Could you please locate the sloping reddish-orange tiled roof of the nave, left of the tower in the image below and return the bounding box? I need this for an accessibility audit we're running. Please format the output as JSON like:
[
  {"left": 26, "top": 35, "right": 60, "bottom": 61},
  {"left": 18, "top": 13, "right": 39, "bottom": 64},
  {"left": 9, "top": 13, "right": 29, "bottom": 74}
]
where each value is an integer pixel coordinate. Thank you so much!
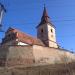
[{"left": 2, "top": 28, "right": 44, "bottom": 46}]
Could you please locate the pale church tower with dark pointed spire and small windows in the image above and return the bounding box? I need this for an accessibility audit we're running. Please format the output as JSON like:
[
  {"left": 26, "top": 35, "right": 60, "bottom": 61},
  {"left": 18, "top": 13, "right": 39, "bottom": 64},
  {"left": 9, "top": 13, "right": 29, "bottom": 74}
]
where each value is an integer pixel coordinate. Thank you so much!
[{"left": 37, "top": 6, "right": 58, "bottom": 48}]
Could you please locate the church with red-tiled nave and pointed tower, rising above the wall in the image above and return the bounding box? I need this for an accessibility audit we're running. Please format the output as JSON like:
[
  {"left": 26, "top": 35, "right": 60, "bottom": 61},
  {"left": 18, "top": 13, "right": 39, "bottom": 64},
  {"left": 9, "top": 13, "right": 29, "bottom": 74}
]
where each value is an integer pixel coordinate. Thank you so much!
[{"left": 2, "top": 6, "right": 59, "bottom": 48}]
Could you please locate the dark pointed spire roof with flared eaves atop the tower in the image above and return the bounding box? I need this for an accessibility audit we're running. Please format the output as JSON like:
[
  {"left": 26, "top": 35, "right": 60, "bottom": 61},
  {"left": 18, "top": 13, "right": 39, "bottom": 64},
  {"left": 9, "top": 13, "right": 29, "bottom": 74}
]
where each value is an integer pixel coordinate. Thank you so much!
[{"left": 37, "top": 6, "right": 55, "bottom": 27}]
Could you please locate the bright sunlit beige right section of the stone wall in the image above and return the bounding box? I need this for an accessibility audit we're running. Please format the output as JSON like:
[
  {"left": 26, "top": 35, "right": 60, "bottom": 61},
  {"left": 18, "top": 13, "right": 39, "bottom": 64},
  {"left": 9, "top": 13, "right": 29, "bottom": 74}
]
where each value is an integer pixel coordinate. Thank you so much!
[{"left": 33, "top": 45, "right": 75, "bottom": 64}]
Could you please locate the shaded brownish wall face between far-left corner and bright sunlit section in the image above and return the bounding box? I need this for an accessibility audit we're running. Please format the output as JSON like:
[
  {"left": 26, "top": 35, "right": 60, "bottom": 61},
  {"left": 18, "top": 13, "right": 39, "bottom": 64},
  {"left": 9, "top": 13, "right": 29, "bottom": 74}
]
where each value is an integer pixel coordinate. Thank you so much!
[{"left": 7, "top": 46, "right": 34, "bottom": 66}]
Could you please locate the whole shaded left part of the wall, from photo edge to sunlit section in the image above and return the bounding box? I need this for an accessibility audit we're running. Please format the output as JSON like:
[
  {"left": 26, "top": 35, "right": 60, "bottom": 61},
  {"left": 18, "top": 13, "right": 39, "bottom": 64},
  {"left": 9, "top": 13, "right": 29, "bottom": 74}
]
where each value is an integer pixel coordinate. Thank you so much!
[{"left": 0, "top": 46, "right": 34, "bottom": 66}]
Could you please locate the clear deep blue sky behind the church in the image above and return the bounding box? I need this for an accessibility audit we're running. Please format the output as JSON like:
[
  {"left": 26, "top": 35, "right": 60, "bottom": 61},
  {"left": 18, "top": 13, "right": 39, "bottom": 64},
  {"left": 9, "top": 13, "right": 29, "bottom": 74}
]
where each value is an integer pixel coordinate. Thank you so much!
[{"left": 0, "top": 0, "right": 75, "bottom": 52}]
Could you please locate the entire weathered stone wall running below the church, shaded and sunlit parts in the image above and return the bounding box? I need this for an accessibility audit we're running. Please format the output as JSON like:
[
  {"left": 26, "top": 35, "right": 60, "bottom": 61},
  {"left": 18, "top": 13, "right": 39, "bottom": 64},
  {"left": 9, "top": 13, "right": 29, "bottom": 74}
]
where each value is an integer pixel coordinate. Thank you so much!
[{"left": 0, "top": 45, "right": 75, "bottom": 66}]
